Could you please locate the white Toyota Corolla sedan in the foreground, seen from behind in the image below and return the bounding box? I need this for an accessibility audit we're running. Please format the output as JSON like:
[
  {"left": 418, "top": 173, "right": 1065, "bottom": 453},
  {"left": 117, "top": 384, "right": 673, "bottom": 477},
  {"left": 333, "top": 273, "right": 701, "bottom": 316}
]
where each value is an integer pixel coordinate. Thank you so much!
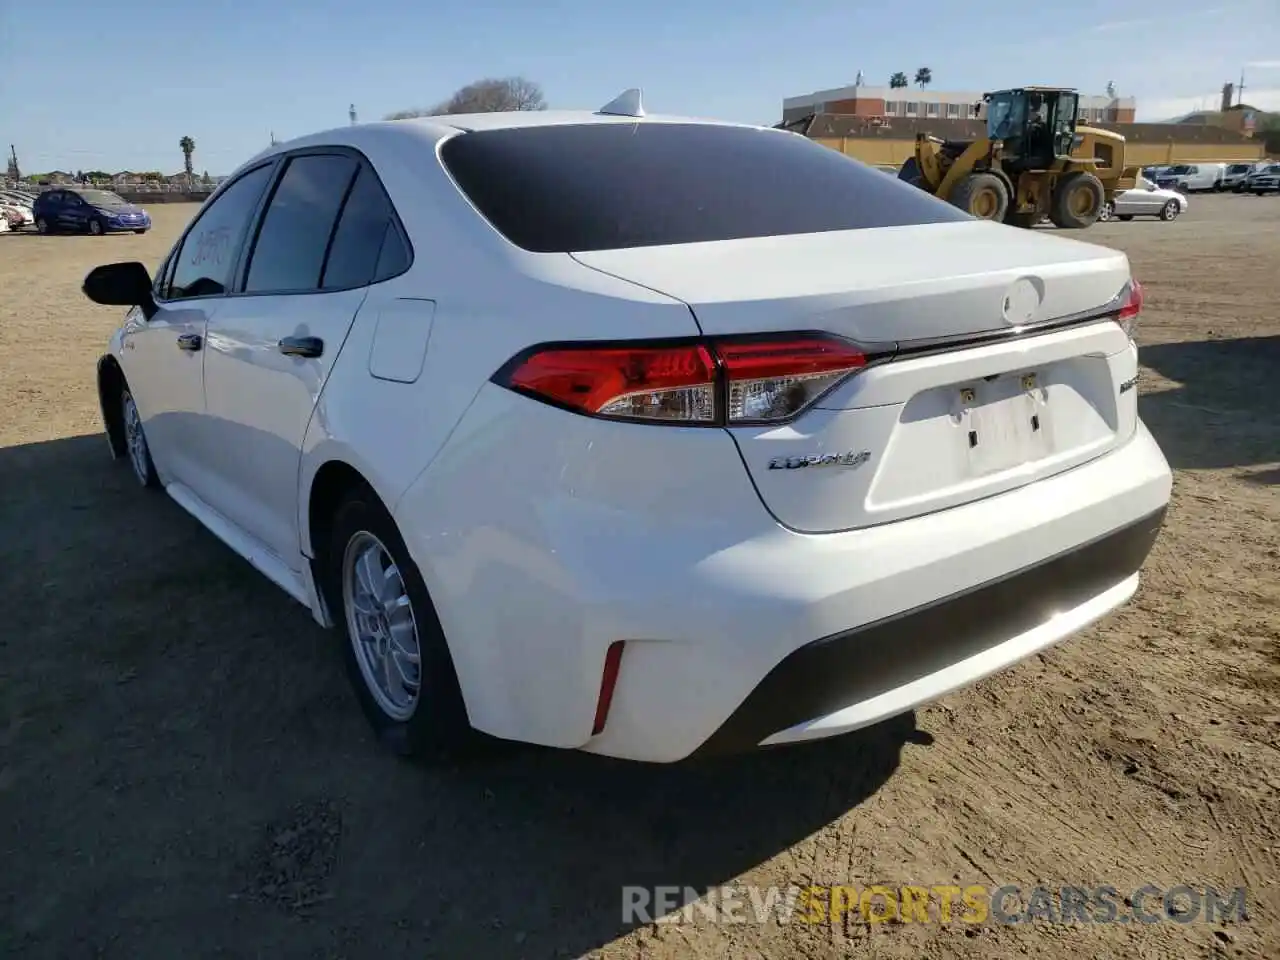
[{"left": 84, "top": 91, "right": 1171, "bottom": 762}]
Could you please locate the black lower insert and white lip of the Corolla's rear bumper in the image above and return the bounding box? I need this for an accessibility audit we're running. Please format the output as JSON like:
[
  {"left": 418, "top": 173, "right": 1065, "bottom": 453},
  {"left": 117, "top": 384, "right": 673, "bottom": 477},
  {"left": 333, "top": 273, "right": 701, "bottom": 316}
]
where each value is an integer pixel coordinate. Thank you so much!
[{"left": 696, "top": 508, "right": 1165, "bottom": 755}]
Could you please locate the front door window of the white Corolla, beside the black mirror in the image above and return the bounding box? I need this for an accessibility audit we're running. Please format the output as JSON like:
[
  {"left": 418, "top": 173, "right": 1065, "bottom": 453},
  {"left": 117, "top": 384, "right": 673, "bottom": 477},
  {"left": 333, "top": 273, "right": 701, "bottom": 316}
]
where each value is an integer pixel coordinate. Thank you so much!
[{"left": 168, "top": 164, "right": 271, "bottom": 300}]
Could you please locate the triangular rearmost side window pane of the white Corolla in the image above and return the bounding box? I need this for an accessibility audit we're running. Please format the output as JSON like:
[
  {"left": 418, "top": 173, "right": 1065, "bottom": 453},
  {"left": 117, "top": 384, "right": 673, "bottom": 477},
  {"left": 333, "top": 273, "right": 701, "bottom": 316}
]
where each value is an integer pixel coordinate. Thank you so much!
[{"left": 320, "top": 166, "right": 408, "bottom": 291}]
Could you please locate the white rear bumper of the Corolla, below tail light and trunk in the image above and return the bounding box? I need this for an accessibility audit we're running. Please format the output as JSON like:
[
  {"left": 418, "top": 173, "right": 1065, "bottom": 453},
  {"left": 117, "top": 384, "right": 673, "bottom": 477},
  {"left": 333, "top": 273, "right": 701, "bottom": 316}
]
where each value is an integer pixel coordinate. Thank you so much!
[{"left": 393, "top": 378, "right": 1171, "bottom": 763}]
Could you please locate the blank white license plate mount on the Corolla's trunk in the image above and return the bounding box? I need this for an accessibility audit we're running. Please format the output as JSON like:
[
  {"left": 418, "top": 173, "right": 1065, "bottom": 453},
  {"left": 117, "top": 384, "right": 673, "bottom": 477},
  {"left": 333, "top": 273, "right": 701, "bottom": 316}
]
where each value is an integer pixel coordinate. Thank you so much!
[{"left": 954, "top": 371, "right": 1053, "bottom": 476}]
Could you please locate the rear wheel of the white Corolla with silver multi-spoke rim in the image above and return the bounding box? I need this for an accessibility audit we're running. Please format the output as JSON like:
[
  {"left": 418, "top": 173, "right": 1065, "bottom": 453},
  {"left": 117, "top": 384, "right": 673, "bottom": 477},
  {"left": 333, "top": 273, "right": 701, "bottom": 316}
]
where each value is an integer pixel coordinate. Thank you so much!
[{"left": 324, "top": 488, "right": 481, "bottom": 760}]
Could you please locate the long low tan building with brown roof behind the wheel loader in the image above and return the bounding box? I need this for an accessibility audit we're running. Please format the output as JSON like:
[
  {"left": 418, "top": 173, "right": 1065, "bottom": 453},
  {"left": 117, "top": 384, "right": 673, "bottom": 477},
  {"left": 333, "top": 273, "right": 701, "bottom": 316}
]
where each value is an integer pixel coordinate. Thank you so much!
[{"left": 778, "top": 113, "right": 1266, "bottom": 166}]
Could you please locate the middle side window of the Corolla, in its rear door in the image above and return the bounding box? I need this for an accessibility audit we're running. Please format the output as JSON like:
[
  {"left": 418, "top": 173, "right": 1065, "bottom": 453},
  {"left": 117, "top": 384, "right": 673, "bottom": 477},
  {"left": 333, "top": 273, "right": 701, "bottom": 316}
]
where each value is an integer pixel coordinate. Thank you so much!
[{"left": 244, "top": 155, "right": 357, "bottom": 293}]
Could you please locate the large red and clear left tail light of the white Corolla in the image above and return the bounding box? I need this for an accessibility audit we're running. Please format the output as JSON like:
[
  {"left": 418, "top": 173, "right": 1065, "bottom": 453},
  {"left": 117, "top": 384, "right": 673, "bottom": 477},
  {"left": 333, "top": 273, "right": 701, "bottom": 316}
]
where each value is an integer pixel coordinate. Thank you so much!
[{"left": 494, "top": 333, "right": 869, "bottom": 426}]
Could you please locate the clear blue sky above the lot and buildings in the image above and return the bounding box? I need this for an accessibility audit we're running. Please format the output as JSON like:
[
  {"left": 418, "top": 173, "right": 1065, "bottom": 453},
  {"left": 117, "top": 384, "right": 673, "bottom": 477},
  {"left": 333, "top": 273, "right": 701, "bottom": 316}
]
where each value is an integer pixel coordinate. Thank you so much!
[{"left": 0, "top": 0, "right": 1280, "bottom": 174}]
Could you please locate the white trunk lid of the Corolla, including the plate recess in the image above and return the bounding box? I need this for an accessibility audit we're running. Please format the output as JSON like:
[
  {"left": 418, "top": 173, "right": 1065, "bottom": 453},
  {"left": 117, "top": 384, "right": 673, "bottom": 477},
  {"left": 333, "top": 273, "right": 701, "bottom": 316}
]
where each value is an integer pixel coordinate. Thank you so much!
[{"left": 573, "top": 220, "right": 1137, "bottom": 532}]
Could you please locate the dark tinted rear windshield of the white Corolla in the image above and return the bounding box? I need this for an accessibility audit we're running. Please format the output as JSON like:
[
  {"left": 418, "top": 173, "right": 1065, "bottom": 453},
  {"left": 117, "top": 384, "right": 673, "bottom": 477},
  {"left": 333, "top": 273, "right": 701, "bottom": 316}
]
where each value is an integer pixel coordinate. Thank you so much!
[{"left": 440, "top": 122, "right": 969, "bottom": 253}]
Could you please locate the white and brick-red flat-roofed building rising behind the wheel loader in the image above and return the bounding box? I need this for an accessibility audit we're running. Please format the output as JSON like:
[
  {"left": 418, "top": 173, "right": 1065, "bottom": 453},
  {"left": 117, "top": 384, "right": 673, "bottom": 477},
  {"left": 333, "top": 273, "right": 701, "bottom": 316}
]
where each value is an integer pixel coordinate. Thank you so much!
[{"left": 782, "top": 84, "right": 1137, "bottom": 123}]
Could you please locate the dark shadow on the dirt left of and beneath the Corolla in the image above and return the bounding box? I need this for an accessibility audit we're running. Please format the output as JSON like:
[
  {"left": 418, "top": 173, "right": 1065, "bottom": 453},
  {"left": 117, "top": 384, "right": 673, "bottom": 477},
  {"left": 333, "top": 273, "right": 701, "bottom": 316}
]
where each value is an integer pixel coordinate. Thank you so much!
[{"left": 0, "top": 435, "right": 928, "bottom": 960}]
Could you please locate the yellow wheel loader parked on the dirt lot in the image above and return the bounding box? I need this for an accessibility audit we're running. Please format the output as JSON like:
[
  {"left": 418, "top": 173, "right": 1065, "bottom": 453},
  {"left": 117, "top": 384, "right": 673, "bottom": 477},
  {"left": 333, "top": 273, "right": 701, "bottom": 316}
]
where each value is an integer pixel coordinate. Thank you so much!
[{"left": 897, "top": 87, "right": 1139, "bottom": 229}]
